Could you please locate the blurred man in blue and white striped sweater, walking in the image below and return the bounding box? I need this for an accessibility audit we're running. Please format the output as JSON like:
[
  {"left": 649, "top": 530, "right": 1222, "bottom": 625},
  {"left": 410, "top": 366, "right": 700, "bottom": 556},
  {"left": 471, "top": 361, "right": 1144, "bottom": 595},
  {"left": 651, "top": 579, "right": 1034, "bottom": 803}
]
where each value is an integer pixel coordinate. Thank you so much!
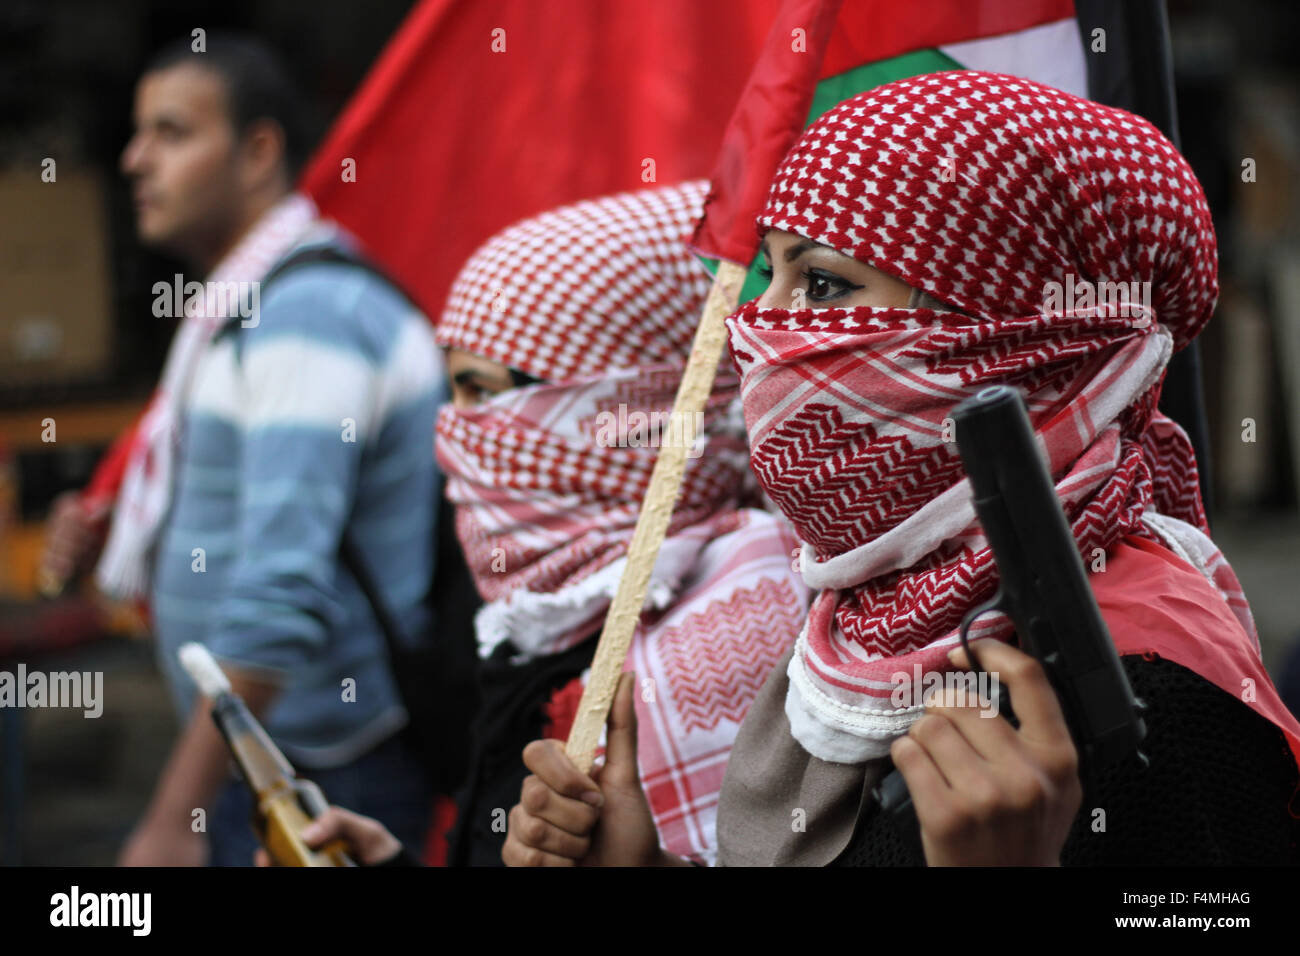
[{"left": 47, "top": 34, "right": 446, "bottom": 865}]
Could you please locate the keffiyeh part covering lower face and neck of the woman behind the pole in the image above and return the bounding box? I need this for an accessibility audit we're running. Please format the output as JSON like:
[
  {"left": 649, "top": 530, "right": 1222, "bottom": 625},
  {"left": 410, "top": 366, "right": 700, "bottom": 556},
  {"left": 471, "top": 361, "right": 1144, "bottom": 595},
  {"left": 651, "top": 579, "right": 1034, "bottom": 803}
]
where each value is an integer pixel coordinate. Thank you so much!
[{"left": 437, "top": 364, "right": 748, "bottom": 657}]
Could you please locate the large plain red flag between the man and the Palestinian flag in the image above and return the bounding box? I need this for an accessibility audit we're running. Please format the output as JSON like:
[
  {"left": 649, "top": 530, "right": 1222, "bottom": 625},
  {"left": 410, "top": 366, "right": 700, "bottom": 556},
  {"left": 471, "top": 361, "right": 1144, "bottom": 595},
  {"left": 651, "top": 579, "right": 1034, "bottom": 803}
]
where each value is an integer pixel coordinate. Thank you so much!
[{"left": 303, "top": 0, "right": 779, "bottom": 319}]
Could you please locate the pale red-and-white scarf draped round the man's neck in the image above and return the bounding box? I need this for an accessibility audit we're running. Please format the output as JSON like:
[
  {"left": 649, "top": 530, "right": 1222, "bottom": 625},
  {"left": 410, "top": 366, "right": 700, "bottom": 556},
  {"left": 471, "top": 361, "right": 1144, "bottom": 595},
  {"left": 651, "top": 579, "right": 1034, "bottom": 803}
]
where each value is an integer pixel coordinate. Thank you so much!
[{"left": 95, "top": 193, "right": 319, "bottom": 600}]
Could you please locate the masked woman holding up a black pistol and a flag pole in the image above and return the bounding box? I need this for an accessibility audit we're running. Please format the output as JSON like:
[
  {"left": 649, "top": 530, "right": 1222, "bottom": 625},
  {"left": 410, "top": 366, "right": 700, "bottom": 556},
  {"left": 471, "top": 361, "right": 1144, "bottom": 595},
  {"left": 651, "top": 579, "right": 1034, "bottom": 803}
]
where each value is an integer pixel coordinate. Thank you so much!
[{"left": 511, "top": 72, "right": 1300, "bottom": 865}]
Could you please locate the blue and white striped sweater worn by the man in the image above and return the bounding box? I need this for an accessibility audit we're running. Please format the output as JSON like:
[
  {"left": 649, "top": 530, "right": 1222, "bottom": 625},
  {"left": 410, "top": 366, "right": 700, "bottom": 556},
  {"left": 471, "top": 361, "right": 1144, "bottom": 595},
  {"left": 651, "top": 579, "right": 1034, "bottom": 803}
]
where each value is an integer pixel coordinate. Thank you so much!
[{"left": 152, "top": 232, "right": 447, "bottom": 767}]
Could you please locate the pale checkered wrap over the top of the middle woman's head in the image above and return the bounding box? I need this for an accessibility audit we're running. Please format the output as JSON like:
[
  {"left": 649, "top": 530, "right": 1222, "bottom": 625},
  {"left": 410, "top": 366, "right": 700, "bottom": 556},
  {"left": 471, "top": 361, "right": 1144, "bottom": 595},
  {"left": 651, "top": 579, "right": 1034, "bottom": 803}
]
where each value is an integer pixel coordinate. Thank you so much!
[{"left": 438, "top": 179, "right": 709, "bottom": 382}]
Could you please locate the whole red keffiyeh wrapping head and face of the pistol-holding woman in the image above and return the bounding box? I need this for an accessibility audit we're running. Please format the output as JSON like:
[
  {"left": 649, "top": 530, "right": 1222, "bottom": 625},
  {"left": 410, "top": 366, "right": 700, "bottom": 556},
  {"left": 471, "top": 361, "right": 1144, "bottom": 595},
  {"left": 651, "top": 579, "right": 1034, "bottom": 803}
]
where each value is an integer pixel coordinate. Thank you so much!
[{"left": 728, "top": 72, "right": 1255, "bottom": 762}]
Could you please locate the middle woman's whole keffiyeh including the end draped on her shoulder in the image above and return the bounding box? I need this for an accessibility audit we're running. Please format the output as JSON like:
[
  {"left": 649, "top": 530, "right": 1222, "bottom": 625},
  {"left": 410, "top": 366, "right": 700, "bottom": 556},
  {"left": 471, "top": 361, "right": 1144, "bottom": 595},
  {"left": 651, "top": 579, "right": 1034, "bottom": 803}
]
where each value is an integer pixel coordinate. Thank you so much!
[{"left": 437, "top": 182, "right": 807, "bottom": 861}]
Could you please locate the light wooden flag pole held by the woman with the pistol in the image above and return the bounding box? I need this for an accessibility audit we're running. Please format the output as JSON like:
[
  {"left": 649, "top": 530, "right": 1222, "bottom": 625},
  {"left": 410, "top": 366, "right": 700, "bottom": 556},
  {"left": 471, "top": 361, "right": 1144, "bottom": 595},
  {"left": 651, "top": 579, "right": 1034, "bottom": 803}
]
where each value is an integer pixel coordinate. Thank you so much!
[{"left": 566, "top": 260, "right": 746, "bottom": 774}]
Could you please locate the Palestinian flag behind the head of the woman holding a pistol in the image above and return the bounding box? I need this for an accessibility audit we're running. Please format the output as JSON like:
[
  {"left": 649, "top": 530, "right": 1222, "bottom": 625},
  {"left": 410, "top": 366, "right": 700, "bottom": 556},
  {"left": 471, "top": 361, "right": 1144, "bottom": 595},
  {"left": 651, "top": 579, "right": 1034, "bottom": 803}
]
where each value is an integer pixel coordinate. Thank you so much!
[{"left": 694, "top": 0, "right": 1212, "bottom": 509}]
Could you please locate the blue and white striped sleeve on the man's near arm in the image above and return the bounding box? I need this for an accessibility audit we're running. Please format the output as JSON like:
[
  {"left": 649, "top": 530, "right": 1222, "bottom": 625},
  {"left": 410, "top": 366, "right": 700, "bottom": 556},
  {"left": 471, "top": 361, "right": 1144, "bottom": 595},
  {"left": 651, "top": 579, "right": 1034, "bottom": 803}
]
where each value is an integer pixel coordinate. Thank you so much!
[{"left": 209, "top": 268, "right": 433, "bottom": 678}]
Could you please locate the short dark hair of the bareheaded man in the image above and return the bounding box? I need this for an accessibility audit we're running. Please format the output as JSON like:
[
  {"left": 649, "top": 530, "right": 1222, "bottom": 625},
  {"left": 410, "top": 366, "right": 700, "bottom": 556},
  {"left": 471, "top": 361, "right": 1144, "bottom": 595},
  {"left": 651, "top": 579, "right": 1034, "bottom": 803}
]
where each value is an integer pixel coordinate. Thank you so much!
[{"left": 144, "top": 30, "right": 313, "bottom": 181}]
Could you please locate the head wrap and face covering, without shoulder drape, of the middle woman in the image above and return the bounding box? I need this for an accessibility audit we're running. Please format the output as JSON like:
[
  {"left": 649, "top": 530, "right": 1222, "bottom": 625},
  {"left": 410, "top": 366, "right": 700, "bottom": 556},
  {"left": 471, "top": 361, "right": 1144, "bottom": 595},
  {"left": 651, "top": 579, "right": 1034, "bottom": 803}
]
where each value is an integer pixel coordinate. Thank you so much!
[{"left": 438, "top": 182, "right": 746, "bottom": 656}]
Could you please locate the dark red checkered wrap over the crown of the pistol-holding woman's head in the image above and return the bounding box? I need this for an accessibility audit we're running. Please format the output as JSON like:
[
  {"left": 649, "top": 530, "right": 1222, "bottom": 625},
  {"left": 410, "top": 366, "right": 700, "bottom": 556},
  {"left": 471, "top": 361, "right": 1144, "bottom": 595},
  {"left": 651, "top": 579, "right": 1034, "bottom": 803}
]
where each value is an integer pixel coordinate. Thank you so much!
[{"left": 758, "top": 72, "right": 1218, "bottom": 349}]
